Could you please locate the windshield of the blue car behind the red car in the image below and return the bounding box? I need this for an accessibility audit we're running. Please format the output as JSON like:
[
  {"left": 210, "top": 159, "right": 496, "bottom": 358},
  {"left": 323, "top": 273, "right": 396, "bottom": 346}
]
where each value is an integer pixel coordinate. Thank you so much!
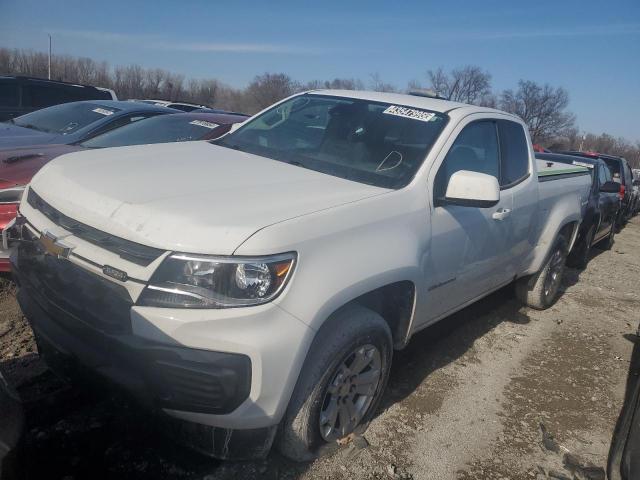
[{"left": 13, "top": 102, "right": 120, "bottom": 135}]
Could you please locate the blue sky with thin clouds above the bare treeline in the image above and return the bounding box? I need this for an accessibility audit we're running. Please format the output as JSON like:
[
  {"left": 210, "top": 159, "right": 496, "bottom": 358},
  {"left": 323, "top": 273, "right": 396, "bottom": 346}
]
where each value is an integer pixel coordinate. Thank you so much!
[{"left": 0, "top": 0, "right": 640, "bottom": 141}]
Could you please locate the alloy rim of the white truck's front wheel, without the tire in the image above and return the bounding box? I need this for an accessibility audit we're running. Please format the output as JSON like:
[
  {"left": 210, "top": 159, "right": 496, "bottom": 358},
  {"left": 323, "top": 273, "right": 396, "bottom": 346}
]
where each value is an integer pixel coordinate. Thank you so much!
[{"left": 319, "top": 344, "right": 382, "bottom": 442}]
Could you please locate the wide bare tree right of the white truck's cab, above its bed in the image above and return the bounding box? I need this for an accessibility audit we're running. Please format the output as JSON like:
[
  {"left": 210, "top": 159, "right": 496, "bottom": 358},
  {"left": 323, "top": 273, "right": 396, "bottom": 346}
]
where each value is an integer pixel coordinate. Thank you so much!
[{"left": 500, "top": 80, "right": 575, "bottom": 143}]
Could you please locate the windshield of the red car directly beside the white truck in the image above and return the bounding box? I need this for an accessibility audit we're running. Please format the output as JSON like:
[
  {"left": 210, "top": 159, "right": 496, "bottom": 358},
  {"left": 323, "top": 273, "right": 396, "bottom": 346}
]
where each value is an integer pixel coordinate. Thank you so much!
[{"left": 80, "top": 113, "right": 218, "bottom": 148}]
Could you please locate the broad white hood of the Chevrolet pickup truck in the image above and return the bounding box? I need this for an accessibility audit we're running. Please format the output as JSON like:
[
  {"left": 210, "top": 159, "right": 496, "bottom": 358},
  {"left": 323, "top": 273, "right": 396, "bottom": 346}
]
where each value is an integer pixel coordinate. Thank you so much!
[{"left": 31, "top": 142, "right": 389, "bottom": 255}]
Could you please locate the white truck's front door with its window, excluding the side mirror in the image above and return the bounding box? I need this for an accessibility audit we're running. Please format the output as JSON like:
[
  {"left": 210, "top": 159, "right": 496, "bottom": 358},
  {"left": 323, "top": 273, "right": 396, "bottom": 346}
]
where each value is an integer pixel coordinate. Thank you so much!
[{"left": 424, "top": 115, "right": 513, "bottom": 320}]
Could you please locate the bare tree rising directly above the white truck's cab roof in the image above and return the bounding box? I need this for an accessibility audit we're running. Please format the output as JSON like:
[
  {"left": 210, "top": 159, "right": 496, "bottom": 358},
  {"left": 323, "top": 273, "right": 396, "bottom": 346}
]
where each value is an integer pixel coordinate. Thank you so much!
[{"left": 427, "top": 65, "right": 491, "bottom": 104}]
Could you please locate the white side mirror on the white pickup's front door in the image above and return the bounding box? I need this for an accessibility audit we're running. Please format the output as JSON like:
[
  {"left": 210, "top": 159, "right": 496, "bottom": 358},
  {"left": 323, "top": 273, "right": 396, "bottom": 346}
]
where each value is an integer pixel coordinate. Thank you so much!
[{"left": 444, "top": 170, "right": 500, "bottom": 208}]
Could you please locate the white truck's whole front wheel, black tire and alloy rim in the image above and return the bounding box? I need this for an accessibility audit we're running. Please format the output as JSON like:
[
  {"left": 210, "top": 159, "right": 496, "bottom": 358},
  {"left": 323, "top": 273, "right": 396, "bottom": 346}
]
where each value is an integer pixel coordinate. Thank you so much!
[{"left": 277, "top": 305, "right": 393, "bottom": 461}]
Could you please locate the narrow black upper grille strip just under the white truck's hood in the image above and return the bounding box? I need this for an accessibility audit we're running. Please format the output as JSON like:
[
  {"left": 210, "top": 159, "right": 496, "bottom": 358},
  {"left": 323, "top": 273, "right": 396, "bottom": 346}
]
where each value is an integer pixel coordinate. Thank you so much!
[{"left": 27, "top": 188, "right": 164, "bottom": 267}]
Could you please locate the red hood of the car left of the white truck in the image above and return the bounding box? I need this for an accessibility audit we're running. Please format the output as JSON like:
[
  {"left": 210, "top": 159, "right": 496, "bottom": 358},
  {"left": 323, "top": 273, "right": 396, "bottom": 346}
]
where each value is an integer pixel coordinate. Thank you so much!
[{"left": 0, "top": 145, "right": 82, "bottom": 188}]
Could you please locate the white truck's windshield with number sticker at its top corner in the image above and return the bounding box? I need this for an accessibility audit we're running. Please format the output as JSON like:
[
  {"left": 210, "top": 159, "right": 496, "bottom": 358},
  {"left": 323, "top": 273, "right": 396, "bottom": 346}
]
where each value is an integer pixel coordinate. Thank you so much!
[{"left": 216, "top": 94, "right": 448, "bottom": 188}]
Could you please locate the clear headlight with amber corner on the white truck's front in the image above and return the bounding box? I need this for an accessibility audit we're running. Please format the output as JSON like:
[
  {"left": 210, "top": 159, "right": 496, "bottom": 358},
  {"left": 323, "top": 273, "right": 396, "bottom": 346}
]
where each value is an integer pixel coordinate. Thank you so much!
[{"left": 138, "top": 253, "right": 296, "bottom": 308}]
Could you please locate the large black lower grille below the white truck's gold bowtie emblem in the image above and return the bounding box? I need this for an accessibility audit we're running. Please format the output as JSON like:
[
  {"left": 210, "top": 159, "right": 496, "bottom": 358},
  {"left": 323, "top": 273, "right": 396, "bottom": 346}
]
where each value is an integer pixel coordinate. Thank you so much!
[{"left": 17, "top": 229, "right": 133, "bottom": 334}]
